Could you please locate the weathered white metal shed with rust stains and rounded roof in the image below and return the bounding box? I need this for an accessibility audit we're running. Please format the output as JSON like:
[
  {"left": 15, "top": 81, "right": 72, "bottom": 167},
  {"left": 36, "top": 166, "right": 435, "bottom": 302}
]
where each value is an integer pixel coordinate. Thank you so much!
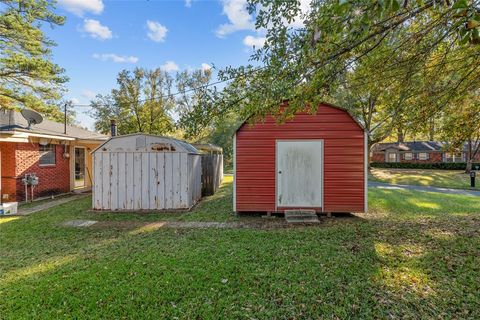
[{"left": 92, "top": 134, "right": 202, "bottom": 211}]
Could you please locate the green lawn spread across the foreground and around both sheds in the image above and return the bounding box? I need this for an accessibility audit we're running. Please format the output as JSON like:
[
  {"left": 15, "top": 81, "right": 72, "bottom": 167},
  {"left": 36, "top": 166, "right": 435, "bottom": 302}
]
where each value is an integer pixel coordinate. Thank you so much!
[{"left": 0, "top": 180, "right": 480, "bottom": 319}]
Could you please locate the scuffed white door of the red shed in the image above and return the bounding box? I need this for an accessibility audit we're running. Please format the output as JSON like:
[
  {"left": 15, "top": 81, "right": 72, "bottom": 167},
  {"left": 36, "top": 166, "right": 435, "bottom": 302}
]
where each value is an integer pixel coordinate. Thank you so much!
[{"left": 277, "top": 140, "right": 323, "bottom": 208}]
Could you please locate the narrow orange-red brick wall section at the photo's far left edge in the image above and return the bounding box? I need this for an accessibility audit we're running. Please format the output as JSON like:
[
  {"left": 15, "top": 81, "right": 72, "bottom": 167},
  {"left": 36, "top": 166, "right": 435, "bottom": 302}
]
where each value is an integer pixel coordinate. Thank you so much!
[{"left": 0, "top": 142, "right": 17, "bottom": 201}]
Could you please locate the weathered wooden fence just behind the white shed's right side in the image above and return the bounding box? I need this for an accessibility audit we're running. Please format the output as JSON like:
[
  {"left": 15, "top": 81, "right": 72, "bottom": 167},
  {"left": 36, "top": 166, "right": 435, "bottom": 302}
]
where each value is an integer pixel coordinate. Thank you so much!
[{"left": 201, "top": 153, "right": 223, "bottom": 197}]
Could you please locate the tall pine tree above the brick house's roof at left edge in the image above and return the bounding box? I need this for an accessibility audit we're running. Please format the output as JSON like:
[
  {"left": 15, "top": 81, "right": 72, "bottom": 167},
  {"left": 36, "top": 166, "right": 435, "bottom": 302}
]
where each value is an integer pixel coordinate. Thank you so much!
[{"left": 0, "top": 0, "right": 67, "bottom": 120}]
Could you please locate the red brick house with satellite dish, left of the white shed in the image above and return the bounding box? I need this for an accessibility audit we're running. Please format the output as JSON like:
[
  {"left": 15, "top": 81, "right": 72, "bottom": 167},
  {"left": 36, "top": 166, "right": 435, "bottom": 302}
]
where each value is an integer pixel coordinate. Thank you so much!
[{"left": 0, "top": 110, "right": 109, "bottom": 202}]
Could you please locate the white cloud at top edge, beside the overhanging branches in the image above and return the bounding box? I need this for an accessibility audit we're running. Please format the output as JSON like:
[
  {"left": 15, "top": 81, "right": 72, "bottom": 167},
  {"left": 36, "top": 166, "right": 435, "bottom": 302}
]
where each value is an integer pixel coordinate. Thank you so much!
[{"left": 216, "top": 0, "right": 255, "bottom": 38}]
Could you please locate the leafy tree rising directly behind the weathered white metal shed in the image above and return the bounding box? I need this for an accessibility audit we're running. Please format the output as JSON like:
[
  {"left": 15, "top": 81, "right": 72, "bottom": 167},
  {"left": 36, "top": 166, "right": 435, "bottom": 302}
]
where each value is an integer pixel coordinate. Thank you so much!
[{"left": 91, "top": 68, "right": 175, "bottom": 135}]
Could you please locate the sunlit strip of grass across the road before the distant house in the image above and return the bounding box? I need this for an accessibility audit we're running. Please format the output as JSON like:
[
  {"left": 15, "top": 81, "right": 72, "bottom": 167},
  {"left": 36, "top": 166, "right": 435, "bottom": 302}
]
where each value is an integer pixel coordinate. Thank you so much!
[{"left": 369, "top": 168, "right": 480, "bottom": 190}]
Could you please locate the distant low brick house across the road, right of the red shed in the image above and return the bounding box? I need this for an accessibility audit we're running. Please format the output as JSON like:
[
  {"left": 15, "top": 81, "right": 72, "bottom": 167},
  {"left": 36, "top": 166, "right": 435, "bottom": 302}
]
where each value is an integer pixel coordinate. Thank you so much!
[{"left": 370, "top": 141, "right": 480, "bottom": 163}]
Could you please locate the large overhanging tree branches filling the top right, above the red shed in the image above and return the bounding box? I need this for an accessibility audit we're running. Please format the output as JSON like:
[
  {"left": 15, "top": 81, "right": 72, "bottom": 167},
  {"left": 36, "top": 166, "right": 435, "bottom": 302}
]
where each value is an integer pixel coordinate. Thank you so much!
[{"left": 220, "top": 0, "right": 480, "bottom": 136}]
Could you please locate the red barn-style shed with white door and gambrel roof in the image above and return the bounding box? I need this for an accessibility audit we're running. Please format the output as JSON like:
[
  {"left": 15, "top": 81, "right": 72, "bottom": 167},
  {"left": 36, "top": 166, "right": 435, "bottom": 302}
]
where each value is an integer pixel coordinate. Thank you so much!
[{"left": 233, "top": 104, "right": 368, "bottom": 212}]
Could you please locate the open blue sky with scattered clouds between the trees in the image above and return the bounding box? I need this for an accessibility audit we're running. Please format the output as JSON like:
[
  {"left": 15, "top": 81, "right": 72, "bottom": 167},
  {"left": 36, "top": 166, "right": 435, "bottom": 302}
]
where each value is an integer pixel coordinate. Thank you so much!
[{"left": 45, "top": 0, "right": 274, "bottom": 128}]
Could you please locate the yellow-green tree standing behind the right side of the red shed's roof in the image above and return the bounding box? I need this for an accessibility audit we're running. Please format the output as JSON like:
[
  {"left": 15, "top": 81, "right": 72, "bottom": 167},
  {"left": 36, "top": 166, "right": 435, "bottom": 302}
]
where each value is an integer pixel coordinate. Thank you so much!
[{"left": 327, "top": 36, "right": 418, "bottom": 155}]
